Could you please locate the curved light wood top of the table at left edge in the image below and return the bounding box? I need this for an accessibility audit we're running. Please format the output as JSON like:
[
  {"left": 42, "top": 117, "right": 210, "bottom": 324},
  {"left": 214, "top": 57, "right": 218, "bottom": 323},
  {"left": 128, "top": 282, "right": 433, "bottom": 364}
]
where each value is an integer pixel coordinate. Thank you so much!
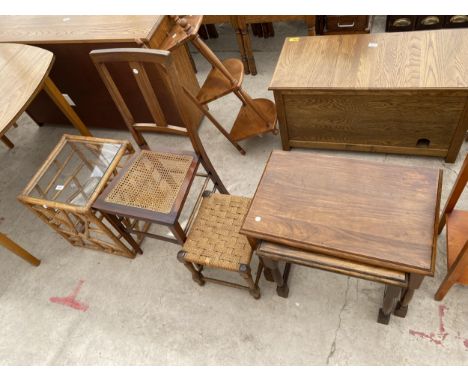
[{"left": 0, "top": 43, "right": 54, "bottom": 136}]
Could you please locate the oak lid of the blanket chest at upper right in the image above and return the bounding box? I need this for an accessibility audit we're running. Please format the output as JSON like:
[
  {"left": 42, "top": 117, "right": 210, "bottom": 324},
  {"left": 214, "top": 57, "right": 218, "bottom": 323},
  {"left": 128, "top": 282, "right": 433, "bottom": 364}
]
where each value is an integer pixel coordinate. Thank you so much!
[{"left": 270, "top": 29, "right": 468, "bottom": 90}]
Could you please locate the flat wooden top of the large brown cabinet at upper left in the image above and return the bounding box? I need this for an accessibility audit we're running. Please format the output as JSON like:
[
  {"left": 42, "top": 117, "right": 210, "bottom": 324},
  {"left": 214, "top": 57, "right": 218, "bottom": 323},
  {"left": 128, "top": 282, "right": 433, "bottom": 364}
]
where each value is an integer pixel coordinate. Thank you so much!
[{"left": 0, "top": 15, "right": 163, "bottom": 44}]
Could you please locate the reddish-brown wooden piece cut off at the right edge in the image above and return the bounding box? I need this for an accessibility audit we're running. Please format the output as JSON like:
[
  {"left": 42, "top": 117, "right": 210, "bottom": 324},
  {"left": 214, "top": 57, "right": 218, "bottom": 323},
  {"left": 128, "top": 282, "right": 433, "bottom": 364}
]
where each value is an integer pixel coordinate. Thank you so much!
[{"left": 434, "top": 155, "right": 468, "bottom": 301}]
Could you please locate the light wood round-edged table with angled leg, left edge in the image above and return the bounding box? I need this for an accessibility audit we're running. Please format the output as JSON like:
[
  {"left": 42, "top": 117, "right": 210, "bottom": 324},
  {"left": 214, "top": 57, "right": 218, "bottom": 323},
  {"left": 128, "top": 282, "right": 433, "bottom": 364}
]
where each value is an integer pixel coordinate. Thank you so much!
[{"left": 0, "top": 44, "right": 91, "bottom": 148}]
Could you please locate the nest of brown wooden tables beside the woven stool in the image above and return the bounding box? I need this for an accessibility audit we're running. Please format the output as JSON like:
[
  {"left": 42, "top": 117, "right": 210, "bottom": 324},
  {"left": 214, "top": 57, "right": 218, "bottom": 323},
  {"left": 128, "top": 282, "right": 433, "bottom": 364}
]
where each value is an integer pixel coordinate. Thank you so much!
[{"left": 240, "top": 151, "right": 442, "bottom": 324}]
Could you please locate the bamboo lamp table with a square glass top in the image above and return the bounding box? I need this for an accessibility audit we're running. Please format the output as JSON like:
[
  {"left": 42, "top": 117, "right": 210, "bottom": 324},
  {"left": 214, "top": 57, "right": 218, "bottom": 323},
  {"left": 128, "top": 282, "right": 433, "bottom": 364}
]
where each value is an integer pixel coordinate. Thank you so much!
[{"left": 18, "top": 135, "right": 141, "bottom": 258}]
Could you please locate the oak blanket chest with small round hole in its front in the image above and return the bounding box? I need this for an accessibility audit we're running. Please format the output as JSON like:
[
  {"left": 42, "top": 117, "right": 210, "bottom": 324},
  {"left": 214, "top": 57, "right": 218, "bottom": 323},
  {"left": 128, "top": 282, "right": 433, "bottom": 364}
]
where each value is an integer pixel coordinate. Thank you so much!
[{"left": 269, "top": 30, "right": 468, "bottom": 162}]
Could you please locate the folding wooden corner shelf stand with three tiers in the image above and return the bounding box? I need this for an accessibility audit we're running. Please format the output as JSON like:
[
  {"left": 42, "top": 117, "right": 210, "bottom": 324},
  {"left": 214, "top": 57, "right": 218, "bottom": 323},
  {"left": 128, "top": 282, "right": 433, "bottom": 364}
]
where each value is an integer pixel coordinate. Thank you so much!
[{"left": 161, "top": 16, "right": 278, "bottom": 154}]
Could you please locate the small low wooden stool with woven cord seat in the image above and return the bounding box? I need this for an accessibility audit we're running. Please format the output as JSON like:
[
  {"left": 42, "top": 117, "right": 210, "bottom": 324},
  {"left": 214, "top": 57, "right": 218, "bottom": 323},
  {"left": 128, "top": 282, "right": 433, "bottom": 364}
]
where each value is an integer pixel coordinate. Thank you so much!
[{"left": 177, "top": 192, "right": 263, "bottom": 299}]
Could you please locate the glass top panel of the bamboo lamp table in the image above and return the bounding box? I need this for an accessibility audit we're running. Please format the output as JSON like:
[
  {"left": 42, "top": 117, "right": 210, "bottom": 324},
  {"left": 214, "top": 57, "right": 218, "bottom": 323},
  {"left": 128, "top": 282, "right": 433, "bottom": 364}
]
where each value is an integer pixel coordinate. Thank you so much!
[{"left": 28, "top": 139, "right": 122, "bottom": 207}]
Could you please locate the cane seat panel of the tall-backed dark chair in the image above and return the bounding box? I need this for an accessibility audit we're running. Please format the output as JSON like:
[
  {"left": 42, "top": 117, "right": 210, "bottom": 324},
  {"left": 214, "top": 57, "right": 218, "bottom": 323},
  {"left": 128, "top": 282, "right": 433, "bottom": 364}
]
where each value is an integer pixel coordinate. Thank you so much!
[{"left": 105, "top": 150, "right": 193, "bottom": 213}]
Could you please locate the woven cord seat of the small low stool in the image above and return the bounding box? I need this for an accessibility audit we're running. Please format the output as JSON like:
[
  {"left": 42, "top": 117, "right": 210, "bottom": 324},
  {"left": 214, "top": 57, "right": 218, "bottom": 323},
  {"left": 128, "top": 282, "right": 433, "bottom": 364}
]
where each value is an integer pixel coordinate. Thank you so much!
[{"left": 183, "top": 194, "right": 252, "bottom": 271}]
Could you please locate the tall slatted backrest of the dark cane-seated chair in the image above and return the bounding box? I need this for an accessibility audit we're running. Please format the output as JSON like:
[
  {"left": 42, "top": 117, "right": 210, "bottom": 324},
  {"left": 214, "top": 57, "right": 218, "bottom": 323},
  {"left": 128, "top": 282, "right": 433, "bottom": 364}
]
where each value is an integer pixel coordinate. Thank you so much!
[{"left": 90, "top": 48, "right": 228, "bottom": 193}]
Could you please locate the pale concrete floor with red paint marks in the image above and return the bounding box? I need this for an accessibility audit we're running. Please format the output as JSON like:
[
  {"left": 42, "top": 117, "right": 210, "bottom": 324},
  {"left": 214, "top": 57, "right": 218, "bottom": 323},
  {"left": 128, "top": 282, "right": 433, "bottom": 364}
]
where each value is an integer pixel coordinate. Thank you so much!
[{"left": 0, "top": 19, "right": 468, "bottom": 365}]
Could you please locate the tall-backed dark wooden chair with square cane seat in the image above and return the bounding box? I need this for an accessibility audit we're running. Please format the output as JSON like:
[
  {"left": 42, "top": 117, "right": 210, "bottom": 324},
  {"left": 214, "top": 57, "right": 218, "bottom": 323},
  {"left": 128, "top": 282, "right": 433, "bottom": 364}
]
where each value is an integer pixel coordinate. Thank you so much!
[{"left": 90, "top": 48, "right": 228, "bottom": 239}]
